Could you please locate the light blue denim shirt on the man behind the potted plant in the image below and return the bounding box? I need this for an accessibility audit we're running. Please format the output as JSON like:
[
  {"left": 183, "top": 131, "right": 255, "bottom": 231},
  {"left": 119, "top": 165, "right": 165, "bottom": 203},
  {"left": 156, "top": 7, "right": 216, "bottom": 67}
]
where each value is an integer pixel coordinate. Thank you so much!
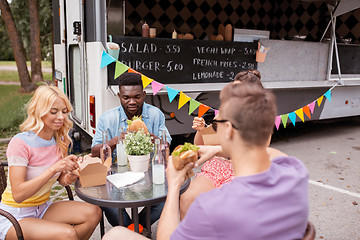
[{"left": 91, "top": 103, "right": 171, "bottom": 159}]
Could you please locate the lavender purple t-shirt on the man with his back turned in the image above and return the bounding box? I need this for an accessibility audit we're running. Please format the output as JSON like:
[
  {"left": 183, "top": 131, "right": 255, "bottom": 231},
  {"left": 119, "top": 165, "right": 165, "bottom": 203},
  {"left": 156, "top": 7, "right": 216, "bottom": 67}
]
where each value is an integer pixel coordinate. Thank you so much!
[{"left": 171, "top": 157, "right": 309, "bottom": 240}]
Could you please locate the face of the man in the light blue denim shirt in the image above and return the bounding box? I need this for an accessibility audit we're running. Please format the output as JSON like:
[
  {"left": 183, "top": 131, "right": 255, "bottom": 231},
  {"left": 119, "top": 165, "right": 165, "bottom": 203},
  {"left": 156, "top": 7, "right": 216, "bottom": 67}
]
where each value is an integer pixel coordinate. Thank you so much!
[{"left": 119, "top": 85, "right": 145, "bottom": 119}]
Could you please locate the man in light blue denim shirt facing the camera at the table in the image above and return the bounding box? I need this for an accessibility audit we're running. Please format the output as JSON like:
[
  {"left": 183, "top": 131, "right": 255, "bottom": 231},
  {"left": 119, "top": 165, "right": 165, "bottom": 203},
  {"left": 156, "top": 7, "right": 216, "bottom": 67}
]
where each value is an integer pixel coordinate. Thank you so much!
[{"left": 91, "top": 73, "right": 171, "bottom": 227}]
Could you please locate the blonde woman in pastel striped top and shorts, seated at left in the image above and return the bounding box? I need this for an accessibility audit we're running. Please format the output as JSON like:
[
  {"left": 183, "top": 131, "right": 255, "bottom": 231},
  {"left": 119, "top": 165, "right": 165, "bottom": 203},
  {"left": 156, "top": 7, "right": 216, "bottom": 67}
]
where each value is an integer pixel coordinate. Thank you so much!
[{"left": 0, "top": 86, "right": 101, "bottom": 240}]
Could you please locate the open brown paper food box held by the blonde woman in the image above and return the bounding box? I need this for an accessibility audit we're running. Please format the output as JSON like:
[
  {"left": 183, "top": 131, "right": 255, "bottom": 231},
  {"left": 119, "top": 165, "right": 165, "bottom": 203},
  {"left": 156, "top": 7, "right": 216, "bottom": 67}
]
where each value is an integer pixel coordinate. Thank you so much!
[{"left": 78, "top": 155, "right": 112, "bottom": 187}]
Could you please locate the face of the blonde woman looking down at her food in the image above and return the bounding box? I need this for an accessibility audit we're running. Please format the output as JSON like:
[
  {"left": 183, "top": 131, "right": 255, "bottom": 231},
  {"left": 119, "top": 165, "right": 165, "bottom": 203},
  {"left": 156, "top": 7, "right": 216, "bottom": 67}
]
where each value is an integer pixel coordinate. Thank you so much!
[{"left": 41, "top": 97, "right": 69, "bottom": 136}]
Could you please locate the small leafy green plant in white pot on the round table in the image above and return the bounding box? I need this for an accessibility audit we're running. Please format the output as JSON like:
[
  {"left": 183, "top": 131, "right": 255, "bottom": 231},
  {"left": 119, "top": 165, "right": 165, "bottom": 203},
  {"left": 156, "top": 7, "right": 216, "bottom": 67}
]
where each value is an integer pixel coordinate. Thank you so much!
[{"left": 124, "top": 131, "right": 154, "bottom": 172}]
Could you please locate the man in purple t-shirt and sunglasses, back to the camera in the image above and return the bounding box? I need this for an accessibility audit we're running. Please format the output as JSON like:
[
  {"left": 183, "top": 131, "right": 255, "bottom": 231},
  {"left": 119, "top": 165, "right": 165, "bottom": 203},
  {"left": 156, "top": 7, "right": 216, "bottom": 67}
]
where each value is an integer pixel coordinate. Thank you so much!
[{"left": 103, "top": 83, "right": 309, "bottom": 240}]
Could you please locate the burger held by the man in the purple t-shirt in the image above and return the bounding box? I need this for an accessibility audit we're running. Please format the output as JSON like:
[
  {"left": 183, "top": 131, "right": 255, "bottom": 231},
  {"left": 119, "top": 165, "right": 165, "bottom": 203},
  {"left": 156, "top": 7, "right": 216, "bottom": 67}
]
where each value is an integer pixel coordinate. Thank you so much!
[{"left": 171, "top": 142, "right": 199, "bottom": 177}]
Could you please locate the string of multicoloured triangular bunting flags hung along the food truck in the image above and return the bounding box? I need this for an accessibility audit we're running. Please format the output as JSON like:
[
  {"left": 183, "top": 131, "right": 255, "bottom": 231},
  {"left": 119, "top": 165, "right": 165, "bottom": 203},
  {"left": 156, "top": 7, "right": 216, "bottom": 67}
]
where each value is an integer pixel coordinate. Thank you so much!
[{"left": 100, "top": 51, "right": 340, "bottom": 130}]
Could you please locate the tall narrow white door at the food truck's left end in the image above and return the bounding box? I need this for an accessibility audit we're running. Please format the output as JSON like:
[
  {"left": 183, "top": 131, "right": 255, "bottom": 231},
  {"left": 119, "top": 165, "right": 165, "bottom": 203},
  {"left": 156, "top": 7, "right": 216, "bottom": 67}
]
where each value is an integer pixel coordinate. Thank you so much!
[{"left": 65, "top": 0, "right": 87, "bottom": 127}]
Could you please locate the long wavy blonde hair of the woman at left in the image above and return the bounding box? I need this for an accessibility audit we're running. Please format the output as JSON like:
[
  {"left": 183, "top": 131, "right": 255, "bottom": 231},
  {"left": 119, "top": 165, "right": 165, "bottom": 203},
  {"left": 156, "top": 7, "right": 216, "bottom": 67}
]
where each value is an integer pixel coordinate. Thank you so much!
[{"left": 20, "top": 85, "right": 73, "bottom": 157}]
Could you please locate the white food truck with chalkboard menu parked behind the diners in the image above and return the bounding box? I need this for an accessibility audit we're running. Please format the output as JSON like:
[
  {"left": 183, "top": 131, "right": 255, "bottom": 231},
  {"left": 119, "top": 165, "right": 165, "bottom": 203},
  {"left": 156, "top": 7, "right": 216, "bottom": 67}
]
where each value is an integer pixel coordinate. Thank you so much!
[{"left": 52, "top": 0, "right": 360, "bottom": 142}]
